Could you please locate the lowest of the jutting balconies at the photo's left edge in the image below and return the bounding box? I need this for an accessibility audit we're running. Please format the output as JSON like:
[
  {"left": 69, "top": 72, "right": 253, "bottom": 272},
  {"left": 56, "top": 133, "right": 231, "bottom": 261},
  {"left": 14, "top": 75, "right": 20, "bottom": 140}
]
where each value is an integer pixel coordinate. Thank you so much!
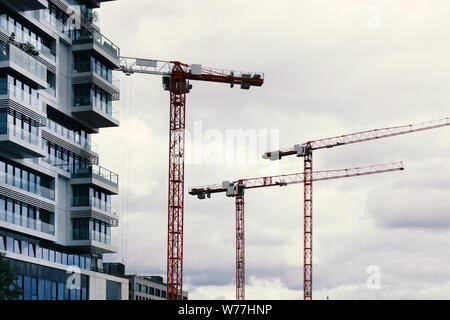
[{"left": 0, "top": 122, "right": 46, "bottom": 159}]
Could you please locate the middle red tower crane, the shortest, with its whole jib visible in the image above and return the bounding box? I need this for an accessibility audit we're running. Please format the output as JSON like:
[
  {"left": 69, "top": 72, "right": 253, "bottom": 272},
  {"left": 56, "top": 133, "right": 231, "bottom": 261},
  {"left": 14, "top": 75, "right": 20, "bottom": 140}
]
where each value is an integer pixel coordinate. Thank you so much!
[{"left": 189, "top": 162, "right": 404, "bottom": 300}]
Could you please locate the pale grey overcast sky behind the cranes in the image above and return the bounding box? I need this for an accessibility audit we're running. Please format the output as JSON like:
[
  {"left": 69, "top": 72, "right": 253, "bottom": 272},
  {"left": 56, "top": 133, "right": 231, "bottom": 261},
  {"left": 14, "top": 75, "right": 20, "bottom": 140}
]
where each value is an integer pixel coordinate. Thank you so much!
[{"left": 95, "top": 0, "right": 450, "bottom": 299}]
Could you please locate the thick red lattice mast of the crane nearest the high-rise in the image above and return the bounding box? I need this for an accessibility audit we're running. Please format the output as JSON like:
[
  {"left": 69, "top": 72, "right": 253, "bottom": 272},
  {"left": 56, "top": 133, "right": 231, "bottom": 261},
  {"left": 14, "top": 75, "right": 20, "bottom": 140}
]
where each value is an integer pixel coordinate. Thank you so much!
[{"left": 167, "top": 72, "right": 187, "bottom": 300}]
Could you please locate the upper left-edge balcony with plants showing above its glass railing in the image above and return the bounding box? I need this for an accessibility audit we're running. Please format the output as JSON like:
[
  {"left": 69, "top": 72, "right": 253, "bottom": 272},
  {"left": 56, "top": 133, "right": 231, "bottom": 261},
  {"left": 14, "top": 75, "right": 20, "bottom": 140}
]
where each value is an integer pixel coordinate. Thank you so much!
[{"left": 0, "top": 42, "right": 47, "bottom": 89}]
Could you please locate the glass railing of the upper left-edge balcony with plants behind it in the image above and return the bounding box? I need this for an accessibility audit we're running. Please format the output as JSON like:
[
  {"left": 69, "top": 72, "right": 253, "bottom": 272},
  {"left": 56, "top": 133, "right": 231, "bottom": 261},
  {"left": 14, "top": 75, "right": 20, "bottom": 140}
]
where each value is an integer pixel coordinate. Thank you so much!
[{"left": 0, "top": 42, "right": 47, "bottom": 82}]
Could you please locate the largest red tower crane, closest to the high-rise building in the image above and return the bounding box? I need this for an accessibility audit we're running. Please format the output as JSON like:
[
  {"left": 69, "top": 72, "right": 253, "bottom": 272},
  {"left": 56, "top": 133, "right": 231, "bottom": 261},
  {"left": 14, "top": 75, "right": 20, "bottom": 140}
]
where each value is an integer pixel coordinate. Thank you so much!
[{"left": 119, "top": 57, "right": 264, "bottom": 300}]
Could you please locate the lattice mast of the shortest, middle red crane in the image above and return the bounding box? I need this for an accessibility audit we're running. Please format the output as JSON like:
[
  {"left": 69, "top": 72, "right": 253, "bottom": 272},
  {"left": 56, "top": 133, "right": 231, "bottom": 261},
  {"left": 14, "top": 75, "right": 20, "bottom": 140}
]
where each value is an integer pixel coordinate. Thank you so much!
[{"left": 235, "top": 193, "right": 245, "bottom": 300}]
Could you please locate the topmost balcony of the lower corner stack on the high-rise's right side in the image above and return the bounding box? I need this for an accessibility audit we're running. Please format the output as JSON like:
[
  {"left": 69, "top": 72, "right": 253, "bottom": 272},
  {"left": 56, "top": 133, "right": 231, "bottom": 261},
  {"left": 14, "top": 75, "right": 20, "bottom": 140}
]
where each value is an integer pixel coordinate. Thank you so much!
[{"left": 70, "top": 165, "right": 119, "bottom": 194}]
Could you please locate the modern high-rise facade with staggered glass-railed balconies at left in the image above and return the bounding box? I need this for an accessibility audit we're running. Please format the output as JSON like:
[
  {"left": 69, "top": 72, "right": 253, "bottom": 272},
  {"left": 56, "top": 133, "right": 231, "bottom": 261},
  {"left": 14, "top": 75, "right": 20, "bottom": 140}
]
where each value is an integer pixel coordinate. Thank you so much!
[{"left": 0, "top": 0, "right": 128, "bottom": 300}]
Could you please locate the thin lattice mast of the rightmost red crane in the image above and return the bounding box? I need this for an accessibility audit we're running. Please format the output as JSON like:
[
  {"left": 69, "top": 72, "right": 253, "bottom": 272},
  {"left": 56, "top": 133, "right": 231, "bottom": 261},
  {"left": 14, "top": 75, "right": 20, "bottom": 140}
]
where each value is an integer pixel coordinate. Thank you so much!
[{"left": 303, "top": 150, "right": 313, "bottom": 300}]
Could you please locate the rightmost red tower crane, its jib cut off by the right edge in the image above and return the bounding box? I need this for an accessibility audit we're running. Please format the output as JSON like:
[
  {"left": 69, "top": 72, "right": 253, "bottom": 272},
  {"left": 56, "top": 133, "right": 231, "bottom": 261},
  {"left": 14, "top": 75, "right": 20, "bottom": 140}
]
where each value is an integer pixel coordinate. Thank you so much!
[{"left": 263, "top": 118, "right": 450, "bottom": 300}]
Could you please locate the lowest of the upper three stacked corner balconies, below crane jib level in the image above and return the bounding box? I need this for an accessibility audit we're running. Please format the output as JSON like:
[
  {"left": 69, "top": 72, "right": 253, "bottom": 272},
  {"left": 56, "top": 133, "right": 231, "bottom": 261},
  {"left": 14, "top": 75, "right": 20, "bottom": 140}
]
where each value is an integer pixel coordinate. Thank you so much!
[{"left": 72, "top": 96, "right": 120, "bottom": 128}]
